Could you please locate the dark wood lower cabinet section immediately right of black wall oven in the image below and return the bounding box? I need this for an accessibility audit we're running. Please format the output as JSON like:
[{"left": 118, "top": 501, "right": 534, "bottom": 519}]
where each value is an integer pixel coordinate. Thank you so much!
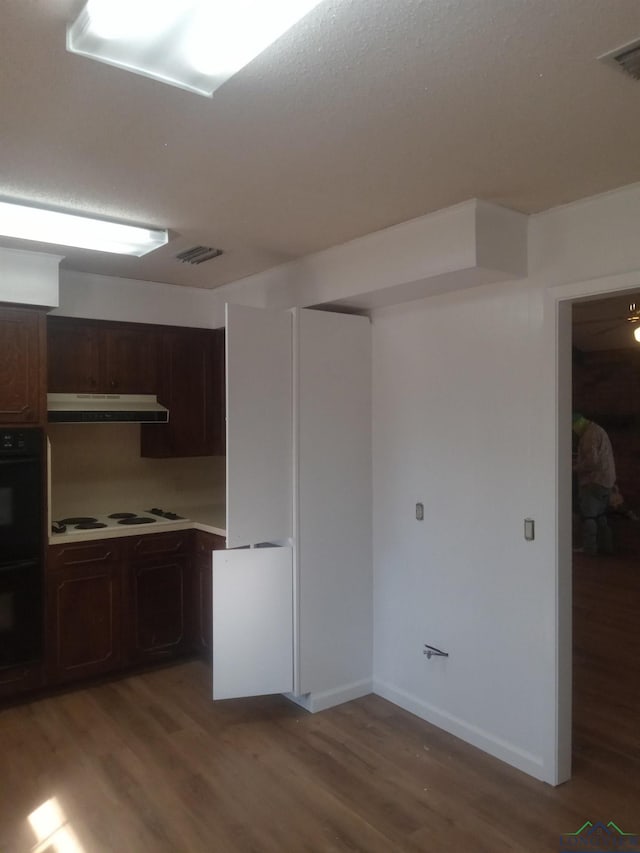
[{"left": 46, "top": 540, "right": 122, "bottom": 684}]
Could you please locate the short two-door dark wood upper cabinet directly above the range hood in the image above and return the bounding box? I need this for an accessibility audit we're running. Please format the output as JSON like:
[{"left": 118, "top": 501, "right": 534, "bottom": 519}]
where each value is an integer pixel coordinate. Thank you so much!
[{"left": 48, "top": 317, "right": 159, "bottom": 394}]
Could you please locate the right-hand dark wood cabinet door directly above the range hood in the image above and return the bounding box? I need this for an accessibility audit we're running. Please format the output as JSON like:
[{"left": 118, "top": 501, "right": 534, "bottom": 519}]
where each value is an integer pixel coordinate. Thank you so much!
[{"left": 104, "top": 326, "right": 159, "bottom": 394}]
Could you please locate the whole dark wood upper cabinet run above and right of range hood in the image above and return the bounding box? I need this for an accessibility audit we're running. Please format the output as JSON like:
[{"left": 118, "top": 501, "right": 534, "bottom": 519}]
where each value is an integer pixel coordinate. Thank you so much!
[{"left": 47, "top": 316, "right": 225, "bottom": 459}]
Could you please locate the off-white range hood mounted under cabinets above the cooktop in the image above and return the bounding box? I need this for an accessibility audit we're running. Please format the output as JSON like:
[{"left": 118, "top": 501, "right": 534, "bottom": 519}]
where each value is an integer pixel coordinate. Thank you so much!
[{"left": 47, "top": 394, "right": 169, "bottom": 424}]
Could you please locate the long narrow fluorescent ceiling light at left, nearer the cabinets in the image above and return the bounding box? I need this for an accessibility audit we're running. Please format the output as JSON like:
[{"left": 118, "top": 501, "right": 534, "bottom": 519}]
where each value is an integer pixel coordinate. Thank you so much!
[{"left": 0, "top": 201, "right": 168, "bottom": 258}]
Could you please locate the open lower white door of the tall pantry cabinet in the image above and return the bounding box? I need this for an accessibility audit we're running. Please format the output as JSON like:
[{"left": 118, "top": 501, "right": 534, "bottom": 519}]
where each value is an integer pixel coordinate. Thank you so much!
[{"left": 213, "top": 548, "right": 293, "bottom": 699}]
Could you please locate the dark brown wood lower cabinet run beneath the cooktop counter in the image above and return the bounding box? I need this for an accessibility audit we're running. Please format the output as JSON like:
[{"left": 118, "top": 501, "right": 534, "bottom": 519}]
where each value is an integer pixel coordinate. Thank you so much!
[{"left": 44, "top": 530, "right": 220, "bottom": 696}]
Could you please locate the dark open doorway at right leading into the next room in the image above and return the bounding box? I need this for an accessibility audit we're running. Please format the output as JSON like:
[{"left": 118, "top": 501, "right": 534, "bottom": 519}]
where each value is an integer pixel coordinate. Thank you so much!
[{"left": 572, "top": 286, "right": 640, "bottom": 778}]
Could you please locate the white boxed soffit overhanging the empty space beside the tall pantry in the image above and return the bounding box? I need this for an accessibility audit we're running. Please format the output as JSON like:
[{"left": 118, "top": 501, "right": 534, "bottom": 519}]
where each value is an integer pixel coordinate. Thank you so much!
[{"left": 283, "top": 199, "right": 528, "bottom": 310}]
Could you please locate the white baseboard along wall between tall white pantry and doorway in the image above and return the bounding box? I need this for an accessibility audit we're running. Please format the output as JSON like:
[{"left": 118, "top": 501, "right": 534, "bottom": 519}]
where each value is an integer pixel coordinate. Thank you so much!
[{"left": 373, "top": 680, "right": 547, "bottom": 782}]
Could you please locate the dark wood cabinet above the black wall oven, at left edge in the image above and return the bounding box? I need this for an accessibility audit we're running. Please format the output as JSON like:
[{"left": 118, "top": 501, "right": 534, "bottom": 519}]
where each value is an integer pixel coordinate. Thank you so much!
[{"left": 0, "top": 306, "right": 46, "bottom": 424}]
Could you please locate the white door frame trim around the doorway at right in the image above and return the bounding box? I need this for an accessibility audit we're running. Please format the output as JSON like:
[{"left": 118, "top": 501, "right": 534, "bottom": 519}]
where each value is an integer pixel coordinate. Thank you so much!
[{"left": 544, "top": 270, "right": 640, "bottom": 785}]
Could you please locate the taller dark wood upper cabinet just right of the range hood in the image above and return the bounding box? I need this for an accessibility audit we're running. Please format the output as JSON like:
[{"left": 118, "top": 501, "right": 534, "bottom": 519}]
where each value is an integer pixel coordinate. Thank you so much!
[{"left": 141, "top": 328, "right": 225, "bottom": 458}]
